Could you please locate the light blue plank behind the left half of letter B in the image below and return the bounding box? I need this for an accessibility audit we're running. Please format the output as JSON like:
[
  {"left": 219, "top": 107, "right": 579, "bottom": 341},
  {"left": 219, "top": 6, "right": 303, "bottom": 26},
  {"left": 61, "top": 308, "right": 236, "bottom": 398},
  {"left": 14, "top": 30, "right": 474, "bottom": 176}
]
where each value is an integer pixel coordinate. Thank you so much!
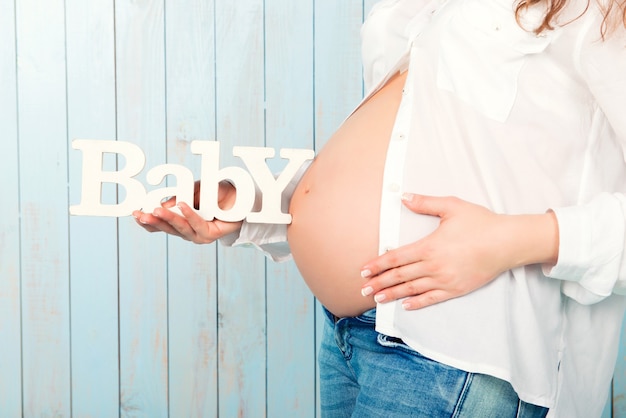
[{"left": 66, "top": 0, "right": 119, "bottom": 418}]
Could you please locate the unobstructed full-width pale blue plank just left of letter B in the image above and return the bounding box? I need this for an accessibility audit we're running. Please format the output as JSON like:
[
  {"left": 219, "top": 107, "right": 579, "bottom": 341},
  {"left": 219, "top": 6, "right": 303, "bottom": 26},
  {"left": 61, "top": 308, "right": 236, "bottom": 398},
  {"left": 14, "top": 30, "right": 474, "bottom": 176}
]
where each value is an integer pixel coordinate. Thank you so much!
[{"left": 16, "top": 0, "right": 71, "bottom": 416}]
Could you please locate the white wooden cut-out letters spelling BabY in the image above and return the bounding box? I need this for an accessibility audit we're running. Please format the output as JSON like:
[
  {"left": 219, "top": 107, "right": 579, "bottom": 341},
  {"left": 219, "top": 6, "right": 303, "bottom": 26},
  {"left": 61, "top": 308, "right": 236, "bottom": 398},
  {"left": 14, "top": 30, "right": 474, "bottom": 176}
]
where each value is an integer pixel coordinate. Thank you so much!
[{"left": 70, "top": 139, "right": 314, "bottom": 224}]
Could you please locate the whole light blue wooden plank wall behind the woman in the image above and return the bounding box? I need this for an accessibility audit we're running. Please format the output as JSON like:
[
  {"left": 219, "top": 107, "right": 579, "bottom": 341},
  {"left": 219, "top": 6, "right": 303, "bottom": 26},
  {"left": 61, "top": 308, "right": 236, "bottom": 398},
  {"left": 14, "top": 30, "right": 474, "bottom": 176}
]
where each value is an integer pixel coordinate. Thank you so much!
[{"left": 0, "top": 0, "right": 626, "bottom": 418}]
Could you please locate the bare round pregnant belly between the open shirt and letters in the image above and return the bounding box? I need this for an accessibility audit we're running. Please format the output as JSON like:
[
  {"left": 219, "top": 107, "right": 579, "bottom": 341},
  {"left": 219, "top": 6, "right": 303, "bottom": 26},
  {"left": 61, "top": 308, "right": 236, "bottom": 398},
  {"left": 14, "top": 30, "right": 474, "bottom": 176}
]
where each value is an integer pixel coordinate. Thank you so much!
[{"left": 287, "top": 73, "right": 406, "bottom": 317}]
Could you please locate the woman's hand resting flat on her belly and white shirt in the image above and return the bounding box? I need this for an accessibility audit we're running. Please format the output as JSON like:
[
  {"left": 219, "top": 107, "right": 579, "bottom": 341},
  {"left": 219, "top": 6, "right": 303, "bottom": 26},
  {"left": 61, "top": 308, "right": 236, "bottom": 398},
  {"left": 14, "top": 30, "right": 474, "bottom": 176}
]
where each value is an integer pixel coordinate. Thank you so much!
[{"left": 361, "top": 194, "right": 559, "bottom": 310}]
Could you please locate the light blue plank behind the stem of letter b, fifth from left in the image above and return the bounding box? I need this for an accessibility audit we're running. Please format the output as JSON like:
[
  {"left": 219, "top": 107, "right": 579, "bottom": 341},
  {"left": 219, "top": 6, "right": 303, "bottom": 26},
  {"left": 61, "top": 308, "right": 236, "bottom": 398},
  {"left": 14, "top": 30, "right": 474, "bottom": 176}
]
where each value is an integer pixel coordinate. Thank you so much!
[{"left": 165, "top": 0, "right": 218, "bottom": 417}]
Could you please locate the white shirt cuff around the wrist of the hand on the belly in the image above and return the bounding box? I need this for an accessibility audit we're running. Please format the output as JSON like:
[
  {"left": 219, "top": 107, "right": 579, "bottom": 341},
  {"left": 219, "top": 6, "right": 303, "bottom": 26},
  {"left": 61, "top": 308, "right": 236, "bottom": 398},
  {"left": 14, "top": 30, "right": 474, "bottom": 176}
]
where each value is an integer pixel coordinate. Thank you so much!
[{"left": 543, "top": 193, "right": 624, "bottom": 304}]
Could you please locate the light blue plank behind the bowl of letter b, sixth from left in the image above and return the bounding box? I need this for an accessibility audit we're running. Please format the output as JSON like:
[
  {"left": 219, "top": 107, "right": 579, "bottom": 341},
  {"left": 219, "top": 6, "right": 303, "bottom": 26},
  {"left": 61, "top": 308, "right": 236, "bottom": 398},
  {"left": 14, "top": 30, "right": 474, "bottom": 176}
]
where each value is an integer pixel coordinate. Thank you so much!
[{"left": 215, "top": 0, "right": 266, "bottom": 417}]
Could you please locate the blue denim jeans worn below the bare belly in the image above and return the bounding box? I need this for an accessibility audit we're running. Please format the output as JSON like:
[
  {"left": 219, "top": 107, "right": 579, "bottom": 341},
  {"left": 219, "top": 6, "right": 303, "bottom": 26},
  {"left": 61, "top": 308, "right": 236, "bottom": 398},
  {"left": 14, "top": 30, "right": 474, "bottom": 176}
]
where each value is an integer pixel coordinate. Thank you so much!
[{"left": 319, "top": 309, "right": 548, "bottom": 418}]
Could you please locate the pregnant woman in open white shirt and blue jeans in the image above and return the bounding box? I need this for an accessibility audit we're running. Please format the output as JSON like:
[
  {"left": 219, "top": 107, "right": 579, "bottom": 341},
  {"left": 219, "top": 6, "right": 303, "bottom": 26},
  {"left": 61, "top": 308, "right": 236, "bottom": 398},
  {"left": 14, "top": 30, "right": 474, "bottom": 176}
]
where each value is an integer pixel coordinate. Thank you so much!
[{"left": 134, "top": 0, "right": 626, "bottom": 418}]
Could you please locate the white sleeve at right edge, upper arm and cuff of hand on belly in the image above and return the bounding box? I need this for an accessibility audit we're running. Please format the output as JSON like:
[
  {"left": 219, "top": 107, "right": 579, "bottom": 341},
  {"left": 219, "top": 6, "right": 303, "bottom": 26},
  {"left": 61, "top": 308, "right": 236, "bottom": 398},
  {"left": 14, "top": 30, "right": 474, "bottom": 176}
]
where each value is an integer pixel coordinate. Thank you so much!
[{"left": 544, "top": 18, "right": 626, "bottom": 304}]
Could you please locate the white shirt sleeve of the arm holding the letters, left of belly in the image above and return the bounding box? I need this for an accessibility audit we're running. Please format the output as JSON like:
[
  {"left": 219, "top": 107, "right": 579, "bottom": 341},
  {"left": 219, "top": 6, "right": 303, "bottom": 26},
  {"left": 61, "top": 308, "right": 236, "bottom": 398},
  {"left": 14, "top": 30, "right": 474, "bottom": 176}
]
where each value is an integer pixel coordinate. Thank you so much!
[{"left": 220, "top": 160, "right": 311, "bottom": 262}]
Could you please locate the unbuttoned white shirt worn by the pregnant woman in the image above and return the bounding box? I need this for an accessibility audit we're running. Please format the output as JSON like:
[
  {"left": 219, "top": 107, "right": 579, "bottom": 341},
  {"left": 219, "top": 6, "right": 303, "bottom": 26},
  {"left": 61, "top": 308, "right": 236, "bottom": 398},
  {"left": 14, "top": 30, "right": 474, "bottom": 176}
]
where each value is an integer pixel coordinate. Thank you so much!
[{"left": 228, "top": 0, "right": 626, "bottom": 418}]
